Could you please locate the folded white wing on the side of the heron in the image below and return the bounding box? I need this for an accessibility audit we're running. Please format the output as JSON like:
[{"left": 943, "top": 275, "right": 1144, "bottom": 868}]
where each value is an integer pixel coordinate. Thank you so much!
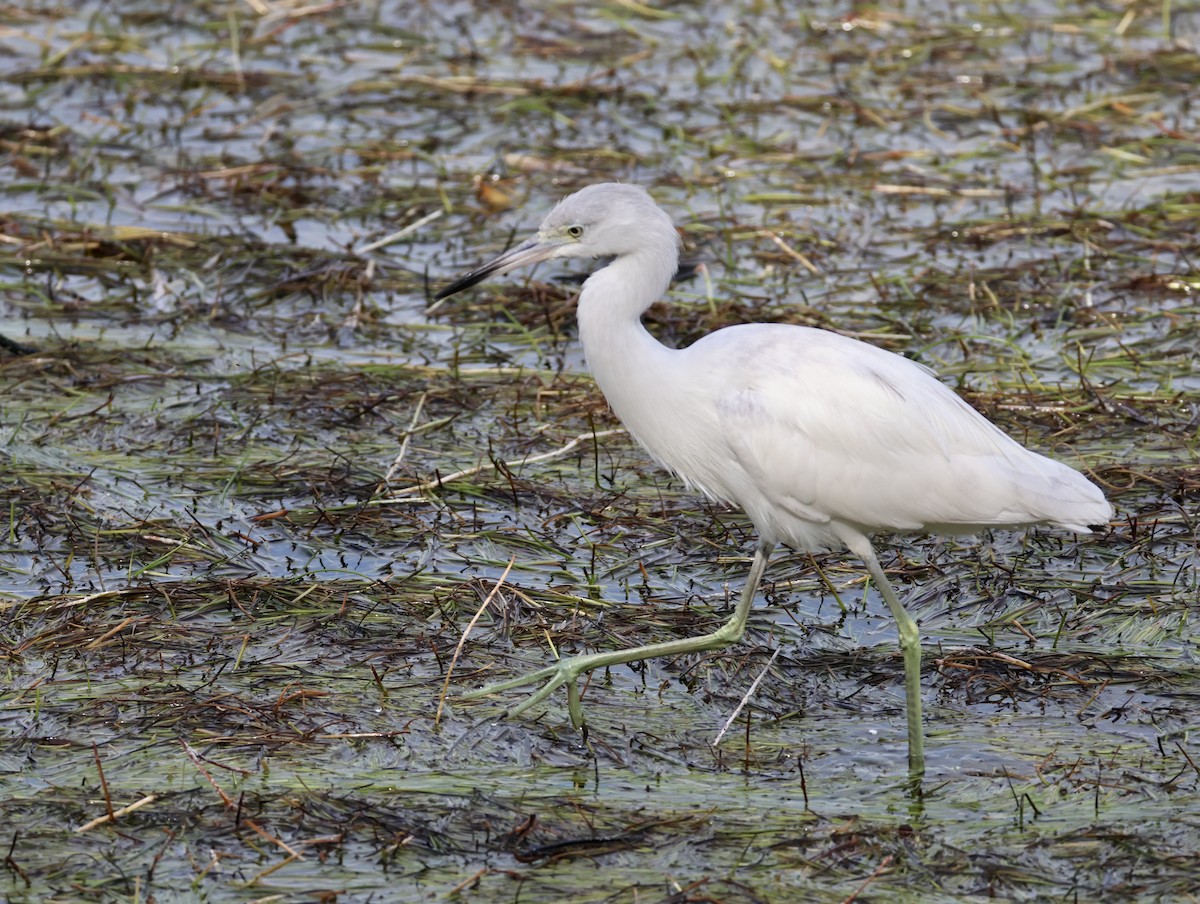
[{"left": 713, "top": 327, "right": 1106, "bottom": 531}]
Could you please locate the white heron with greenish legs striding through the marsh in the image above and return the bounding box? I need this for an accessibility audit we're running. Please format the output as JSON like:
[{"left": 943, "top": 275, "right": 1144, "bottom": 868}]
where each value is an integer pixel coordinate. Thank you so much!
[{"left": 437, "top": 182, "right": 1112, "bottom": 777}]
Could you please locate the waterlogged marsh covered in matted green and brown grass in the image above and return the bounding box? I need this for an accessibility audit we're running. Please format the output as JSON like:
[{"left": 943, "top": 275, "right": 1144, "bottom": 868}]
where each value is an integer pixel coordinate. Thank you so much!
[{"left": 0, "top": 0, "right": 1200, "bottom": 903}]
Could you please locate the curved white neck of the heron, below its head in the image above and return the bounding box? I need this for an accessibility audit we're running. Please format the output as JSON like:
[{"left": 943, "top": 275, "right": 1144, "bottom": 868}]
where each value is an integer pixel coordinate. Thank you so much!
[{"left": 577, "top": 247, "right": 678, "bottom": 412}]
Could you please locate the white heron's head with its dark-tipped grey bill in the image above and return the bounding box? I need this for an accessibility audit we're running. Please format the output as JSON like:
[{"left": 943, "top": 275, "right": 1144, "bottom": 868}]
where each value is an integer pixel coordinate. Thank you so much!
[{"left": 437, "top": 182, "right": 679, "bottom": 299}]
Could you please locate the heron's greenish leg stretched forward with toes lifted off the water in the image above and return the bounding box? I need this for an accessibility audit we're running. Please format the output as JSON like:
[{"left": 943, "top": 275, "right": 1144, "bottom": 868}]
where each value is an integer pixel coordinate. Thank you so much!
[{"left": 461, "top": 544, "right": 777, "bottom": 729}]
